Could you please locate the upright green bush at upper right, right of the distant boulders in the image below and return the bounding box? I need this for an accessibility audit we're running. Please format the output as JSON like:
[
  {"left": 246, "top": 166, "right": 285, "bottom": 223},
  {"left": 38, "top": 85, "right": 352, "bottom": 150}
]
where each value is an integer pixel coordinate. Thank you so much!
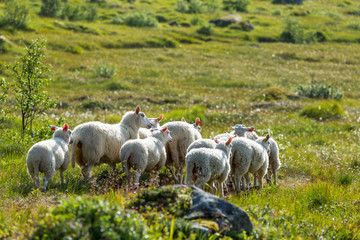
[{"left": 280, "top": 18, "right": 305, "bottom": 43}]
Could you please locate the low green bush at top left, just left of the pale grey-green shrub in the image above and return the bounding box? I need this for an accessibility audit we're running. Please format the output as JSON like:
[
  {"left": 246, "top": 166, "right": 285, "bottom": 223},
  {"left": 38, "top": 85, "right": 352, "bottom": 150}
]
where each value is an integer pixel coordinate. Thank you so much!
[{"left": 59, "top": 3, "right": 98, "bottom": 22}]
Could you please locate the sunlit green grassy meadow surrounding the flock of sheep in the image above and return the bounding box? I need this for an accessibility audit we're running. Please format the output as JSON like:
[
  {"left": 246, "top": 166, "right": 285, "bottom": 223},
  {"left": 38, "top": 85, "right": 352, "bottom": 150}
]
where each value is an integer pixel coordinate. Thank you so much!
[{"left": 0, "top": 0, "right": 360, "bottom": 239}]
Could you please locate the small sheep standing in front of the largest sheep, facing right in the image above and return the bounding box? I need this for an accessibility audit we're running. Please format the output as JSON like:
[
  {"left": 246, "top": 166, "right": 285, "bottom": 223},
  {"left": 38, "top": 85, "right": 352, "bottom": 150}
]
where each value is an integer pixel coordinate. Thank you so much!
[{"left": 120, "top": 127, "right": 172, "bottom": 189}]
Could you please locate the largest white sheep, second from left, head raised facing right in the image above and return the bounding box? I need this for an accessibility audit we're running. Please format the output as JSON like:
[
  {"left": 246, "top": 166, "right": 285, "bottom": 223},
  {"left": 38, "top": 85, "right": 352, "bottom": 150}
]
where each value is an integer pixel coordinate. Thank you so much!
[{"left": 71, "top": 106, "right": 152, "bottom": 180}]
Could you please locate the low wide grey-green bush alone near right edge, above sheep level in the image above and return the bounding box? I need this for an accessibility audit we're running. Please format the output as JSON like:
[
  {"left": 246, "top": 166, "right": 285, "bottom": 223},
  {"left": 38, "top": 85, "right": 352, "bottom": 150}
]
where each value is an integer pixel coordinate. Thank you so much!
[{"left": 295, "top": 83, "right": 344, "bottom": 100}]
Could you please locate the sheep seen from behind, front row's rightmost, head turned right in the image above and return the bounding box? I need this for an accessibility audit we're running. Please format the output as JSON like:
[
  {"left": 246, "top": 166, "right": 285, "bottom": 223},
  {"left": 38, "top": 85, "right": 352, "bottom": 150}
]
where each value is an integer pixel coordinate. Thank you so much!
[{"left": 230, "top": 135, "right": 270, "bottom": 191}]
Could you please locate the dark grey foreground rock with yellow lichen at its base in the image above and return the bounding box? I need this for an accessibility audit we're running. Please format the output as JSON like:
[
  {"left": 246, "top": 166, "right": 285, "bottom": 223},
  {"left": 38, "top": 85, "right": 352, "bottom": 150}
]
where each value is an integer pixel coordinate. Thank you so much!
[{"left": 182, "top": 186, "right": 253, "bottom": 235}]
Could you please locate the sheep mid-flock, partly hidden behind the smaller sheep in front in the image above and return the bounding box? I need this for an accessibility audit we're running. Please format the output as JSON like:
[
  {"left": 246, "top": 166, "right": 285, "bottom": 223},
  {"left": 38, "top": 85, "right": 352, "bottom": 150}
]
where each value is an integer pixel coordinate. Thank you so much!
[{"left": 163, "top": 118, "right": 202, "bottom": 184}]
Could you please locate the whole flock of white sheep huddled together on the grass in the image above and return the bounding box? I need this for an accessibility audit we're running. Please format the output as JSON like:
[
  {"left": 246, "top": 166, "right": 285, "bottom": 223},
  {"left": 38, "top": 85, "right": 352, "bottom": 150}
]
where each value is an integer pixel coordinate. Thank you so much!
[{"left": 26, "top": 106, "right": 281, "bottom": 196}]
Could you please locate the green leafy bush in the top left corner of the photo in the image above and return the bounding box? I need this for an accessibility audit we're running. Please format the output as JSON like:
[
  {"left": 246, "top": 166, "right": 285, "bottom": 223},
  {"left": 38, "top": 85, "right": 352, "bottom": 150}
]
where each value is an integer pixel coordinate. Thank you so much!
[{"left": 0, "top": 0, "right": 29, "bottom": 29}]
